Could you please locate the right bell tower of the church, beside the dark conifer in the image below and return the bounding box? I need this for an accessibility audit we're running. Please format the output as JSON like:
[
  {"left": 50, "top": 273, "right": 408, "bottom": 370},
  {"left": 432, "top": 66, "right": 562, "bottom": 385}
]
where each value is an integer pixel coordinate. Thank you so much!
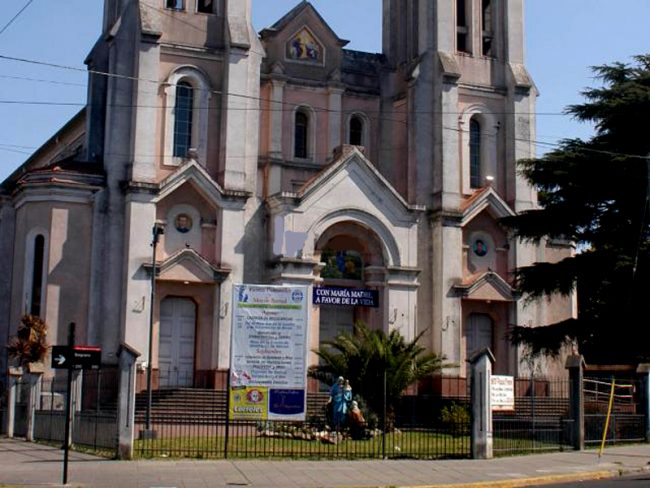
[{"left": 379, "top": 0, "right": 544, "bottom": 374}]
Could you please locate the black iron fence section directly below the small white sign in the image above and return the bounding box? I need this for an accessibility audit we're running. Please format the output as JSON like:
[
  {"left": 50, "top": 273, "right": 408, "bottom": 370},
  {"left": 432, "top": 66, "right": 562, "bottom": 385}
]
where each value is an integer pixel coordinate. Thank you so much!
[{"left": 493, "top": 378, "right": 573, "bottom": 456}]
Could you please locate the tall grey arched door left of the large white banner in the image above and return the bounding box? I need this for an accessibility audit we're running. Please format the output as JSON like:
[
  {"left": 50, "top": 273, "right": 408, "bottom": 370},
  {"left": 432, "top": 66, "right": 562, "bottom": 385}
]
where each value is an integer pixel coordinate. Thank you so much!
[{"left": 158, "top": 297, "right": 196, "bottom": 388}]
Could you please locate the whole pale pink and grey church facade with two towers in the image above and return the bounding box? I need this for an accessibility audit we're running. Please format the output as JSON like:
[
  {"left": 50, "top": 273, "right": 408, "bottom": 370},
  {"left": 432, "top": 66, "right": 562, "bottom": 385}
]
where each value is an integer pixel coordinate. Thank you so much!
[{"left": 0, "top": 0, "right": 575, "bottom": 387}]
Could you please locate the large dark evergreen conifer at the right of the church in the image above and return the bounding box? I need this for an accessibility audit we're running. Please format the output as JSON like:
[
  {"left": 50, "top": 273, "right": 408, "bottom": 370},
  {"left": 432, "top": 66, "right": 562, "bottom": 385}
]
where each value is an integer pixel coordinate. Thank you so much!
[{"left": 503, "top": 55, "right": 650, "bottom": 364}]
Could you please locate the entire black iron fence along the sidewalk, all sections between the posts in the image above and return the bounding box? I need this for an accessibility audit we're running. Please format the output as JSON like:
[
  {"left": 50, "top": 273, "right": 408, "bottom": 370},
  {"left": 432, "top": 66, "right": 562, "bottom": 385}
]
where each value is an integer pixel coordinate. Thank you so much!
[{"left": 3, "top": 369, "right": 647, "bottom": 459}]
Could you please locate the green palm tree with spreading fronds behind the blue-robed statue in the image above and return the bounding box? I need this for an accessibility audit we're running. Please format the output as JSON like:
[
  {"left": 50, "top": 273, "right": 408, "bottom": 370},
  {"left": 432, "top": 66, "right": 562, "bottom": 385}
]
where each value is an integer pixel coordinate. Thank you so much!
[{"left": 309, "top": 322, "right": 449, "bottom": 424}]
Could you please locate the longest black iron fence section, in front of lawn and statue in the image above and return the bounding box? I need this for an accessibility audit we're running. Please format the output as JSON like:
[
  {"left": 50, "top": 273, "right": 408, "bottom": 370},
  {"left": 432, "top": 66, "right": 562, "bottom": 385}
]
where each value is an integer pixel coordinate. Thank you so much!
[{"left": 135, "top": 389, "right": 470, "bottom": 459}]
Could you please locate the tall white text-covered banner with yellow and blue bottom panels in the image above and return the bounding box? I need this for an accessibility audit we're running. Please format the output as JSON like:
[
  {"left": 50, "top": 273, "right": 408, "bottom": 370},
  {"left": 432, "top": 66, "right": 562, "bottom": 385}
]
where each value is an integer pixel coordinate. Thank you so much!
[{"left": 228, "top": 285, "right": 309, "bottom": 420}]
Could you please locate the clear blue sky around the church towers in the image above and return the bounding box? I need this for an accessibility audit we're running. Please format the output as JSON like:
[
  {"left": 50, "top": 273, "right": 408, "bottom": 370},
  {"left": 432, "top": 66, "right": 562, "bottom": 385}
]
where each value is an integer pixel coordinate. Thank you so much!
[{"left": 0, "top": 0, "right": 650, "bottom": 181}]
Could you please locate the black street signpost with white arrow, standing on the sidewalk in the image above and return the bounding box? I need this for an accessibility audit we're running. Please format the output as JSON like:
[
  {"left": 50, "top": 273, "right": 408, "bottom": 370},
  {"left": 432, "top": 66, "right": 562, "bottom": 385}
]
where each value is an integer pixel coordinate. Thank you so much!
[{"left": 52, "top": 322, "right": 102, "bottom": 485}]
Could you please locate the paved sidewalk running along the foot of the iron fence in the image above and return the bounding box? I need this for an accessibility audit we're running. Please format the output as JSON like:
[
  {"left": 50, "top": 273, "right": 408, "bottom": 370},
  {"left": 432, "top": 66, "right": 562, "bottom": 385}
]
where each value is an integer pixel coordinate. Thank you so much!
[{"left": 0, "top": 438, "right": 650, "bottom": 488}]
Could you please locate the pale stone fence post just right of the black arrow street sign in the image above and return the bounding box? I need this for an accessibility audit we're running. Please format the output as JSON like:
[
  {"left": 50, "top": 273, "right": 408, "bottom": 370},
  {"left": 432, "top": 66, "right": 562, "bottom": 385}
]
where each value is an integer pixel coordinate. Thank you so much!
[{"left": 117, "top": 343, "right": 141, "bottom": 459}]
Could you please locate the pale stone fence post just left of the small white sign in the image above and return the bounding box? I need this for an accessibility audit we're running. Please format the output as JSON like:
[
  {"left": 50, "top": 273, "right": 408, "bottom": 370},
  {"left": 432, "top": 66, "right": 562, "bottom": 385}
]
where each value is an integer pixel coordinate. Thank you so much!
[{"left": 469, "top": 348, "right": 494, "bottom": 459}]
